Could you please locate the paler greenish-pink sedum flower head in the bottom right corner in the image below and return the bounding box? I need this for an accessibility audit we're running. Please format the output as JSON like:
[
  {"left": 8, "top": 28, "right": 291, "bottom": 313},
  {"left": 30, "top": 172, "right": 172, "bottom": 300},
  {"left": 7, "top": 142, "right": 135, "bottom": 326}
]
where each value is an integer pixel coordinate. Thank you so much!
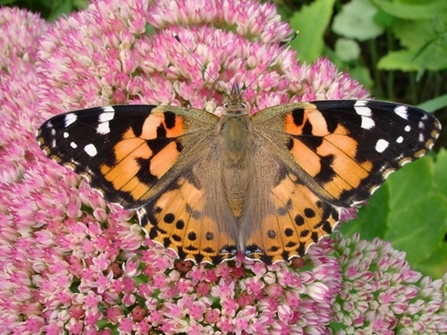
[{"left": 332, "top": 234, "right": 447, "bottom": 335}]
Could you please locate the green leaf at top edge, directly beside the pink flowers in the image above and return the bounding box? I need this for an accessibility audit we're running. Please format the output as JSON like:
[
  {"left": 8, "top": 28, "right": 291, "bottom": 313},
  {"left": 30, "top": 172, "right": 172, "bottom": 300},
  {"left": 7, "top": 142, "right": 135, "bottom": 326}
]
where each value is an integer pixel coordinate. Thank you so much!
[{"left": 290, "top": 0, "right": 335, "bottom": 63}]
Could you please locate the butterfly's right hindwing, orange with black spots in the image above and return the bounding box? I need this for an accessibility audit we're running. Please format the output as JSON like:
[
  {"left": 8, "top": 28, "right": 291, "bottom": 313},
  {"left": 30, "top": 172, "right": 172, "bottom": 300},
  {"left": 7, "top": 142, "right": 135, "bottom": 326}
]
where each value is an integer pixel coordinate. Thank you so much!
[{"left": 239, "top": 142, "right": 339, "bottom": 264}]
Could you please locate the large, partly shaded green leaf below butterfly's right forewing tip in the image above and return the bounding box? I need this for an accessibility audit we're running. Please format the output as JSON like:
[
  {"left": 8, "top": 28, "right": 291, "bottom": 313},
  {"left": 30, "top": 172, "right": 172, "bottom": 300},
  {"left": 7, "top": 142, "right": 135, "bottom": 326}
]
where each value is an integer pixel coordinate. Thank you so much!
[{"left": 340, "top": 154, "right": 447, "bottom": 278}]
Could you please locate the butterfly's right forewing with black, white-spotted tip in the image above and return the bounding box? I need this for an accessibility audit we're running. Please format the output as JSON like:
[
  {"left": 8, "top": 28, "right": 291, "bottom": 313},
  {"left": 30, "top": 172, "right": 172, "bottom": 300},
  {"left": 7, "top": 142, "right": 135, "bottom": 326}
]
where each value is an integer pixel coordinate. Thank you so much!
[{"left": 253, "top": 100, "right": 441, "bottom": 207}]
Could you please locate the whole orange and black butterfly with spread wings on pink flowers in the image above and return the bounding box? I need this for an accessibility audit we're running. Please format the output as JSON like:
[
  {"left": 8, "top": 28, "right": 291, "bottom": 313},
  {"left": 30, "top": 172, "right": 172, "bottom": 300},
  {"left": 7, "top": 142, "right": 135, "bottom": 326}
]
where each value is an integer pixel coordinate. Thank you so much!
[{"left": 36, "top": 85, "right": 441, "bottom": 264}]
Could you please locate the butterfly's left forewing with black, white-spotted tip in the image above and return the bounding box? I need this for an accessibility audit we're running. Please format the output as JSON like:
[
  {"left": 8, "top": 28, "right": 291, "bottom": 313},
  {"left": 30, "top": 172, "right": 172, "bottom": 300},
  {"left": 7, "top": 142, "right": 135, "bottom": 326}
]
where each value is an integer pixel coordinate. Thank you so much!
[{"left": 37, "top": 105, "right": 218, "bottom": 208}]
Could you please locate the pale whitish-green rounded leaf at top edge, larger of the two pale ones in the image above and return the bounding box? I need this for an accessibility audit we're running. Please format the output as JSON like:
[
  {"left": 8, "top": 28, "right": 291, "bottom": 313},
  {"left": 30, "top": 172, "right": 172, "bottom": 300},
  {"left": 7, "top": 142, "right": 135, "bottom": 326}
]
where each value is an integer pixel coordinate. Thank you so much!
[{"left": 332, "top": 0, "right": 383, "bottom": 41}]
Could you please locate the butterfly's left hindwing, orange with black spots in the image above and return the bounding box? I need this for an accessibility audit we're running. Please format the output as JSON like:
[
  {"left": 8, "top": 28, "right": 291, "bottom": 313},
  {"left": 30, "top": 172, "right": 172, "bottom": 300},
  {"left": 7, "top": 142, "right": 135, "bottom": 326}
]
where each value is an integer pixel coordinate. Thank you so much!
[{"left": 137, "top": 141, "right": 237, "bottom": 264}]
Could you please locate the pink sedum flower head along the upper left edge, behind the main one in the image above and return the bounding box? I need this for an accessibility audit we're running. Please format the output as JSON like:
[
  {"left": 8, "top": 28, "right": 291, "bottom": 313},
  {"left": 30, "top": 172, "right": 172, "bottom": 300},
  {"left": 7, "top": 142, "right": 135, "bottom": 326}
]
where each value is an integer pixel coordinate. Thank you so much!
[{"left": 0, "top": 7, "right": 47, "bottom": 183}]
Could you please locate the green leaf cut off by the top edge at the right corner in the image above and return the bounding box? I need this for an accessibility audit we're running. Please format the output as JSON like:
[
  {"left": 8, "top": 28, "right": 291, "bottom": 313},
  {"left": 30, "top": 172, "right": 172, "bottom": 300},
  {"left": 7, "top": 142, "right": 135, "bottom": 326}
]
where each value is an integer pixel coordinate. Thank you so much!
[{"left": 371, "top": 0, "right": 447, "bottom": 20}]
